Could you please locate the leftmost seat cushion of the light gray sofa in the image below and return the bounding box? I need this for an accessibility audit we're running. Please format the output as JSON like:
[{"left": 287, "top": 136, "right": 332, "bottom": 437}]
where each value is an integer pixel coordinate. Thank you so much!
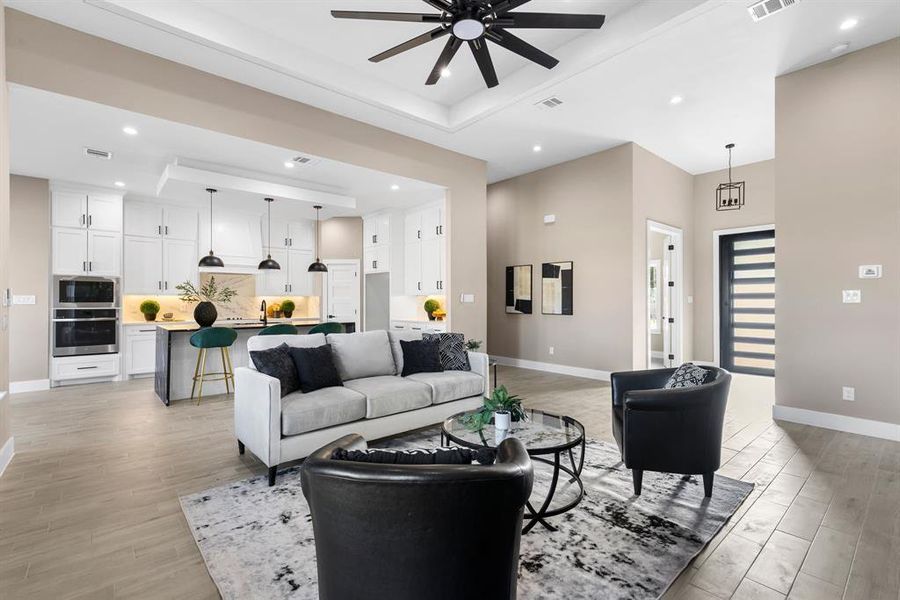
[{"left": 281, "top": 387, "right": 366, "bottom": 436}]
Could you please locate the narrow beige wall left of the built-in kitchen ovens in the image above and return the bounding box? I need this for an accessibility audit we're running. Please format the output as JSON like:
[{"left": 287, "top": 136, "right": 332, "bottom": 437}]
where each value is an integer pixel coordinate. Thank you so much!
[{"left": 9, "top": 175, "right": 50, "bottom": 381}]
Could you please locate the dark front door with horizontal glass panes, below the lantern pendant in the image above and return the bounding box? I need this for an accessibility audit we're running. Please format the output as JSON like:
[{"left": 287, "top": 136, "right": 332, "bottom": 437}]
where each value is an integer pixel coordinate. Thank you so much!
[{"left": 719, "top": 230, "right": 775, "bottom": 377}]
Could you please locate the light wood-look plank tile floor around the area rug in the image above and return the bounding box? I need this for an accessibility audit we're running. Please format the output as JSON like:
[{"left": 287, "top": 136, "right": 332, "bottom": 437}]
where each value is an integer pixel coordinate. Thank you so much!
[{"left": 0, "top": 367, "right": 900, "bottom": 600}]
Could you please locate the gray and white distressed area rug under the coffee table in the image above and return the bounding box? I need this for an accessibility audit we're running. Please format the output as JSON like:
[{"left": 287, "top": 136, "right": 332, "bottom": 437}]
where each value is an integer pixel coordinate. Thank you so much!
[{"left": 181, "top": 429, "right": 753, "bottom": 600}]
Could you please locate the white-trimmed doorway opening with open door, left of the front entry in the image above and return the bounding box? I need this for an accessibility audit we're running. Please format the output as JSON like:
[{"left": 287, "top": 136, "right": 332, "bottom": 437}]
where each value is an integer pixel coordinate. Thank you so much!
[{"left": 645, "top": 221, "right": 684, "bottom": 368}]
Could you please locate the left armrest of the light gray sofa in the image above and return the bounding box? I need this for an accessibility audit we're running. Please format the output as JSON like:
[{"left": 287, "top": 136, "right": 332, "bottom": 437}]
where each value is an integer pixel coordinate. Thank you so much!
[{"left": 234, "top": 367, "right": 281, "bottom": 467}]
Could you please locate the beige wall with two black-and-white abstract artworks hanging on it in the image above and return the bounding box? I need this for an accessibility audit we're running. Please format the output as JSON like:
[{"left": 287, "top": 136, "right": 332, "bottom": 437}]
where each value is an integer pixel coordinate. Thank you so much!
[{"left": 487, "top": 144, "right": 633, "bottom": 371}]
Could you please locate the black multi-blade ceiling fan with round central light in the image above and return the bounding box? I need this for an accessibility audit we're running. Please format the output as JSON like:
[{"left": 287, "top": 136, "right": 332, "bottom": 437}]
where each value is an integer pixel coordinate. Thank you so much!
[{"left": 331, "top": 0, "right": 606, "bottom": 88}]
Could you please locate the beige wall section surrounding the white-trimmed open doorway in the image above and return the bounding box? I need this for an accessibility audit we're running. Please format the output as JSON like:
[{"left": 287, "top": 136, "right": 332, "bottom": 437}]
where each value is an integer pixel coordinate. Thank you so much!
[{"left": 626, "top": 144, "right": 694, "bottom": 369}]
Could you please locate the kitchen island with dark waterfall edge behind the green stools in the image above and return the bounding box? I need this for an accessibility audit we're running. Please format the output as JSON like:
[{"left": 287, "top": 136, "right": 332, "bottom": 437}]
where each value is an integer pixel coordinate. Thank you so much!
[{"left": 154, "top": 319, "right": 356, "bottom": 406}]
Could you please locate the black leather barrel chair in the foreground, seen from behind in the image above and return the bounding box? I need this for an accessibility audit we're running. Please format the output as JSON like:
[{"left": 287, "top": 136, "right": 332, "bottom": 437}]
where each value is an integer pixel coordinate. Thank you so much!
[{"left": 301, "top": 434, "right": 533, "bottom": 600}]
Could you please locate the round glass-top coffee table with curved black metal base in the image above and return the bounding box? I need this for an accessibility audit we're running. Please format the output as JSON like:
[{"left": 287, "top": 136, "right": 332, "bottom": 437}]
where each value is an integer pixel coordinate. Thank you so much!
[{"left": 441, "top": 409, "right": 584, "bottom": 533}]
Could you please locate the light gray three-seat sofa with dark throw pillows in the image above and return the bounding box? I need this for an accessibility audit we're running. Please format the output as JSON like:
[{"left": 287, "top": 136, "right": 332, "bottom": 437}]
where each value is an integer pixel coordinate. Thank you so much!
[{"left": 234, "top": 331, "right": 490, "bottom": 485}]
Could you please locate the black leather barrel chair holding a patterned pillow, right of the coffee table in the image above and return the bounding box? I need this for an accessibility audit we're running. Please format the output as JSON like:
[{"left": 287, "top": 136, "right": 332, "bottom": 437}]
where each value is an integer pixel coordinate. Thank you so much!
[{"left": 611, "top": 367, "right": 731, "bottom": 498}]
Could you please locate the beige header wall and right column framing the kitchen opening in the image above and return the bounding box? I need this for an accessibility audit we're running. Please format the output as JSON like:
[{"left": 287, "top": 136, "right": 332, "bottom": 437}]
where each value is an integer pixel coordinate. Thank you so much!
[{"left": 6, "top": 10, "right": 487, "bottom": 339}]
